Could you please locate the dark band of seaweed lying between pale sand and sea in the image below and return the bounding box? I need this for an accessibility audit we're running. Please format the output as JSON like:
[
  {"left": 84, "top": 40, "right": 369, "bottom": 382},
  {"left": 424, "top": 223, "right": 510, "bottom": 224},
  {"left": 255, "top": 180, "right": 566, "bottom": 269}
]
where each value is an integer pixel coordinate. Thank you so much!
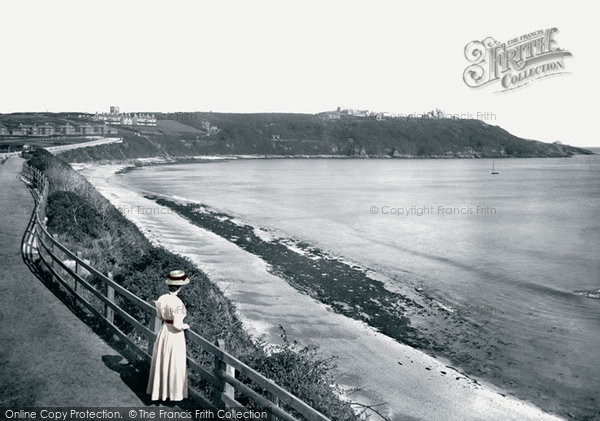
[{"left": 146, "top": 196, "right": 430, "bottom": 349}]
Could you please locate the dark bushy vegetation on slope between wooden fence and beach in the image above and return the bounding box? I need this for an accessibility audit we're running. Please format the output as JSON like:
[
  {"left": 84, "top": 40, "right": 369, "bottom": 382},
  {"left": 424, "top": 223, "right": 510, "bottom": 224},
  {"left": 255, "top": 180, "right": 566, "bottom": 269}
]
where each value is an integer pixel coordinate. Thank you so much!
[{"left": 29, "top": 150, "right": 358, "bottom": 420}]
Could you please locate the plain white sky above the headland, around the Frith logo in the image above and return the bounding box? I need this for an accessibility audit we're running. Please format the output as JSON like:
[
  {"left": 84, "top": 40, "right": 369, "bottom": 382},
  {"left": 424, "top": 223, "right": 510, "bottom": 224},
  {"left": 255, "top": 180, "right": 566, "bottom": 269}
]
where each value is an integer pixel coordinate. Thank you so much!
[{"left": 0, "top": 0, "right": 600, "bottom": 147}]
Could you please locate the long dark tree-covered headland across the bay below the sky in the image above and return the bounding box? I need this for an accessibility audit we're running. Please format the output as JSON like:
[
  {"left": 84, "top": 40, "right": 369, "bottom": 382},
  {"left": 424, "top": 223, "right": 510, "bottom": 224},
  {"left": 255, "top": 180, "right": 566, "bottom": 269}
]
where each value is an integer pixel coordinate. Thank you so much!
[{"left": 2, "top": 113, "right": 592, "bottom": 162}]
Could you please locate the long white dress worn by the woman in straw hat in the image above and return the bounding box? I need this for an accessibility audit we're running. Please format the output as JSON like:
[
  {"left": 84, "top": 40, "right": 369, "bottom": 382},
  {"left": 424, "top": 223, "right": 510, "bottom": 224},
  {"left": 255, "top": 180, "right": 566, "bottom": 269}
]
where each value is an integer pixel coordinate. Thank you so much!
[{"left": 146, "top": 292, "right": 189, "bottom": 401}]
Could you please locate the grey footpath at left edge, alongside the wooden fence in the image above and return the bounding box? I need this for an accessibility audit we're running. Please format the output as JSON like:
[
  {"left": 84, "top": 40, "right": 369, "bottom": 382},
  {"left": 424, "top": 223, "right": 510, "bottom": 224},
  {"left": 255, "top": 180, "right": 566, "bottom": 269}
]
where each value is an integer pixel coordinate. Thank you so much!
[{"left": 0, "top": 157, "right": 149, "bottom": 407}]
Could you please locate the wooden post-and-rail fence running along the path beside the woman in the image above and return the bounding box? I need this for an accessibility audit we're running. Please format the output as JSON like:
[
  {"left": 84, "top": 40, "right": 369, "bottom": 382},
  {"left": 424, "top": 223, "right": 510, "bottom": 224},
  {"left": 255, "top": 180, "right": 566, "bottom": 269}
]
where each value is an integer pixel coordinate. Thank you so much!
[{"left": 22, "top": 164, "right": 328, "bottom": 421}]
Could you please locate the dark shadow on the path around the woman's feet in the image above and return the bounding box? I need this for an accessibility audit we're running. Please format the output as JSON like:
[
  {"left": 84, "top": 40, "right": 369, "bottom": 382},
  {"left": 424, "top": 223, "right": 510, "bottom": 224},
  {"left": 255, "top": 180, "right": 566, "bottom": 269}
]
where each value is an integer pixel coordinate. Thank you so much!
[{"left": 102, "top": 355, "right": 197, "bottom": 409}]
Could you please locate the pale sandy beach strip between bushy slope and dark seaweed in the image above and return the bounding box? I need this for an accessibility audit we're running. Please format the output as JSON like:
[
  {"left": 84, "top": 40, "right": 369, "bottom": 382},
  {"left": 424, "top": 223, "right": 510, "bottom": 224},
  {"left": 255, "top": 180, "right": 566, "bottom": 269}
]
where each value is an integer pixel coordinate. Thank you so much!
[{"left": 74, "top": 165, "right": 560, "bottom": 420}]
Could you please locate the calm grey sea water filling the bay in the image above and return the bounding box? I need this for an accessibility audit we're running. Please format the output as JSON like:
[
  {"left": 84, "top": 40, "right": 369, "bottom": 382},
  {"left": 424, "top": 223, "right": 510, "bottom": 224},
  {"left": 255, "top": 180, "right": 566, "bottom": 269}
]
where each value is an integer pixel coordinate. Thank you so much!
[{"left": 120, "top": 156, "right": 600, "bottom": 416}]
